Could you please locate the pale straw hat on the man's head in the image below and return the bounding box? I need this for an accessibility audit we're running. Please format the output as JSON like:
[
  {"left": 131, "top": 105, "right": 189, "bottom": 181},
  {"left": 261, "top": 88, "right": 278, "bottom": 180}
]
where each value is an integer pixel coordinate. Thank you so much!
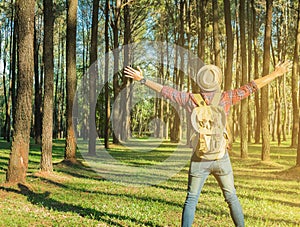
[{"left": 196, "top": 65, "right": 222, "bottom": 92}]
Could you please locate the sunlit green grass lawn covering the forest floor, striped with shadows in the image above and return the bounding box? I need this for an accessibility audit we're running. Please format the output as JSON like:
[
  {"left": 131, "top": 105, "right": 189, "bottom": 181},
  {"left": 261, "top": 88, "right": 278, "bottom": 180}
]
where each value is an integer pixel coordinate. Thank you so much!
[{"left": 0, "top": 137, "right": 300, "bottom": 227}]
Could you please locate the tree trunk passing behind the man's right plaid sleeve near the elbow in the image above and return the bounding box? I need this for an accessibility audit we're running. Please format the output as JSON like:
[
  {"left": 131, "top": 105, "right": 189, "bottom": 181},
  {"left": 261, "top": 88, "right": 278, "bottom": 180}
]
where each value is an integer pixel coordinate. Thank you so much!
[{"left": 239, "top": 0, "right": 248, "bottom": 158}]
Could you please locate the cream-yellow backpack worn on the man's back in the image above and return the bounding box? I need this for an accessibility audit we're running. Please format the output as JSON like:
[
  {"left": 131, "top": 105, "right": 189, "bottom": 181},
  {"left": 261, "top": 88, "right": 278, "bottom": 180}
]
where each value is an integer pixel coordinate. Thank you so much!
[{"left": 191, "top": 93, "right": 228, "bottom": 160}]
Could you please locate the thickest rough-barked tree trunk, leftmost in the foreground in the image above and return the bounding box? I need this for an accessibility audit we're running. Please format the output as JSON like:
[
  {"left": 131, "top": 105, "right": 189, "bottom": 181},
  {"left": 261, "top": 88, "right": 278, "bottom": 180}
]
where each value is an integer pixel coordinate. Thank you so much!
[{"left": 6, "top": 0, "right": 35, "bottom": 183}]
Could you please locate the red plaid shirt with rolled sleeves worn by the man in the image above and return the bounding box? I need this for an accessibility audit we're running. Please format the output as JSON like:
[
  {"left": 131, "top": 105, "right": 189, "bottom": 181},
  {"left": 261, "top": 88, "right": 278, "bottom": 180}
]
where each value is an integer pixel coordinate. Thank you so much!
[{"left": 161, "top": 81, "right": 258, "bottom": 115}]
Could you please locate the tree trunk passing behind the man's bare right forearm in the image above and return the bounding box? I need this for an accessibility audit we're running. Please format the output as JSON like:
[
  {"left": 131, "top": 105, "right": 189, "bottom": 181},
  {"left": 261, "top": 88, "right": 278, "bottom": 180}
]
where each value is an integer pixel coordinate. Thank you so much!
[{"left": 261, "top": 0, "right": 273, "bottom": 161}]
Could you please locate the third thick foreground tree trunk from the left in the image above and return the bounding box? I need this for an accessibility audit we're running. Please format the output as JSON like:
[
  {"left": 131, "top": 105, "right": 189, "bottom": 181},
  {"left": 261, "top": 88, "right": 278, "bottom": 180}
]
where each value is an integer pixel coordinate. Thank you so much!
[{"left": 65, "top": 0, "right": 78, "bottom": 162}]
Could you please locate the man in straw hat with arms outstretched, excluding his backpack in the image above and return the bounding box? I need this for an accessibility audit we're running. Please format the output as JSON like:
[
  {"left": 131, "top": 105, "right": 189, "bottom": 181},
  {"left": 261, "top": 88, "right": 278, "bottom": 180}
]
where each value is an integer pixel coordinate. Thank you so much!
[{"left": 125, "top": 61, "right": 291, "bottom": 226}]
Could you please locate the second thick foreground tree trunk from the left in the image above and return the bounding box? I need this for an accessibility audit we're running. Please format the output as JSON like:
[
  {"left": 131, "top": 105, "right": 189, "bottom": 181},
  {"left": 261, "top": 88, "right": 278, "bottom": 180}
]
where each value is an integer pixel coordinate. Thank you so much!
[{"left": 41, "top": 0, "right": 54, "bottom": 172}]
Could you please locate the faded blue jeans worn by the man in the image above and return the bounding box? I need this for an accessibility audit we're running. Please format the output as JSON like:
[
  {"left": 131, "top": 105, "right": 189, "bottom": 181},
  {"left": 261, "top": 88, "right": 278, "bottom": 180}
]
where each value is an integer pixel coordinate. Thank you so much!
[{"left": 181, "top": 152, "right": 244, "bottom": 227}]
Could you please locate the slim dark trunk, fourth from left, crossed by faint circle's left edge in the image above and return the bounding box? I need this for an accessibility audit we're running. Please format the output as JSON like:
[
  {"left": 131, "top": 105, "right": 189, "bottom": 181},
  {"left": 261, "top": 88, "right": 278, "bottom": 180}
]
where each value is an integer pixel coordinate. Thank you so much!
[{"left": 88, "top": 0, "right": 99, "bottom": 156}]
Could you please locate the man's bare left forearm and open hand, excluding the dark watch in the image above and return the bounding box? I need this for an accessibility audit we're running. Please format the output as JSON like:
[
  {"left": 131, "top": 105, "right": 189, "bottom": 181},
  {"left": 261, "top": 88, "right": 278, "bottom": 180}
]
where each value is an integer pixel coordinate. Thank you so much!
[{"left": 124, "top": 66, "right": 163, "bottom": 92}]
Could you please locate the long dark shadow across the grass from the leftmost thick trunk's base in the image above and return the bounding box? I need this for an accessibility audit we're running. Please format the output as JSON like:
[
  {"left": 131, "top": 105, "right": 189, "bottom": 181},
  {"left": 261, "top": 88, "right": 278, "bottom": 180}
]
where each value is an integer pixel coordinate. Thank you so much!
[{"left": 0, "top": 184, "right": 162, "bottom": 226}]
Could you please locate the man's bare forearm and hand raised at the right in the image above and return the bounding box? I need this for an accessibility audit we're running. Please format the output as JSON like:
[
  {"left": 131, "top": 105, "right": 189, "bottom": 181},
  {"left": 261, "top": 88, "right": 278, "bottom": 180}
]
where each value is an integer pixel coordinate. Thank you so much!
[{"left": 254, "top": 61, "right": 291, "bottom": 89}]
